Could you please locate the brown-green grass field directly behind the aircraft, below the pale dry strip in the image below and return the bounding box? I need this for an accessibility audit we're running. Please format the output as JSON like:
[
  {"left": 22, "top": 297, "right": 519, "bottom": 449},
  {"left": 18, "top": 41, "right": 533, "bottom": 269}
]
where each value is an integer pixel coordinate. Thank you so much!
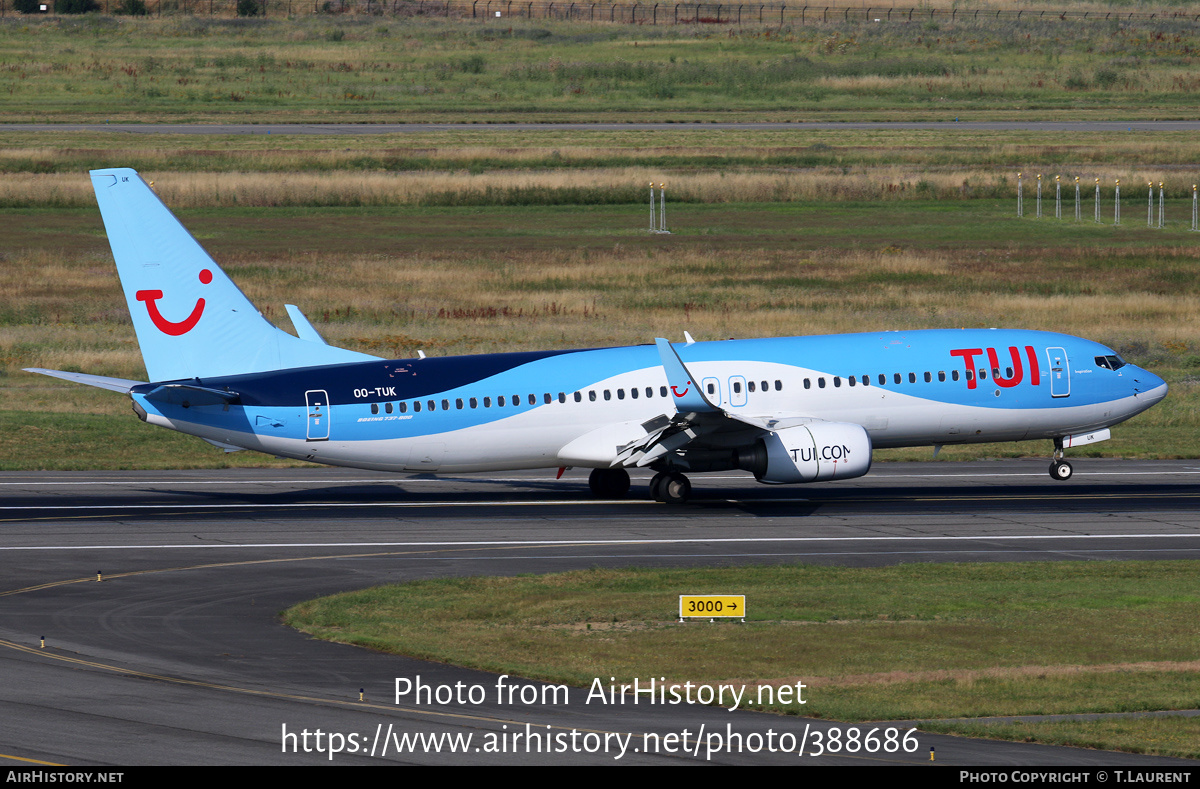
[{"left": 0, "top": 193, "right": 1200, "bottom": 468}]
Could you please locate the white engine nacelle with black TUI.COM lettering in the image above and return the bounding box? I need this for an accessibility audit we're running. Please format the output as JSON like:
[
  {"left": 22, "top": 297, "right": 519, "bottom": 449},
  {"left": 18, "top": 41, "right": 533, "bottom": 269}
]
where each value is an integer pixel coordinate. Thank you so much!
[{"left": 742, "top": 422, "right": 871, "bottom": 484}]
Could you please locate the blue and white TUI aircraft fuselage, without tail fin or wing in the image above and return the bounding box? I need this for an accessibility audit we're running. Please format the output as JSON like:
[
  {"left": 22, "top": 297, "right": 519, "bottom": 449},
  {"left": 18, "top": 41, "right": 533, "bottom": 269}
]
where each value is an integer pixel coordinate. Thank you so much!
[{"left": 132, "top": 330, "right": 1166, "bottom": 471}]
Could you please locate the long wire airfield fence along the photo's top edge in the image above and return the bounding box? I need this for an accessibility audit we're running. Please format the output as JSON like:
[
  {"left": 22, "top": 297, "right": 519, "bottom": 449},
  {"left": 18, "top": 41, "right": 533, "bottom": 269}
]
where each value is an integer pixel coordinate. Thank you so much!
[{"left": 0, "top": 0, "right": 1200, "bottom": 26}]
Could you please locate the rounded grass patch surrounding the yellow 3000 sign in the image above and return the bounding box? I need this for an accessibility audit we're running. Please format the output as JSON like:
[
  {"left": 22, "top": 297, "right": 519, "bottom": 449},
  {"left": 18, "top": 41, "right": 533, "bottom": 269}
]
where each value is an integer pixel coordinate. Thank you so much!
[{"left": 284, "top": 561, "right": 1200, "bottom": 758}]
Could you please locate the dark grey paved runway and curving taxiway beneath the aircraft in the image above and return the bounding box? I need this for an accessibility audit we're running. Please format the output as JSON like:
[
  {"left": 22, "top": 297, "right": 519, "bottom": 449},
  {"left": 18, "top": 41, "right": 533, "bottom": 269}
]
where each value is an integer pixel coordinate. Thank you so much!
[{"left": 0, "top": 459, "right": 1200, "bottom": 765}]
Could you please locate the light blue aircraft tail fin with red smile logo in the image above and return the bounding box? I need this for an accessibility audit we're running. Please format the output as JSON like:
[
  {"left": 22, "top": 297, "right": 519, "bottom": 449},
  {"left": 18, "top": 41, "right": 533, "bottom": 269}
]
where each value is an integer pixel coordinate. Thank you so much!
[{"left": 91, "top": 168, "right": 378, "bottom": 381}]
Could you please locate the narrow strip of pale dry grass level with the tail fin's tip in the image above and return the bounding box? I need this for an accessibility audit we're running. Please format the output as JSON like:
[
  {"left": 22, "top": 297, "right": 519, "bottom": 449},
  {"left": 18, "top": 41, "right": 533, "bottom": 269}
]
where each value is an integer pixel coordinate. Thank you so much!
[{"left": 7, "top": 164, "right": 1200, "bottom": 206}]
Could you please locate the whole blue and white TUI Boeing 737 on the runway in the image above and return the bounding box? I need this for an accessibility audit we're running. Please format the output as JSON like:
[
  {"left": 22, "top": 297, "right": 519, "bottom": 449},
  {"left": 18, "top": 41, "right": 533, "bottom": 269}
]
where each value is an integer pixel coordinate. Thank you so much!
[{"left": 30, "top": 169, "right": 1166, "bottom": 504}]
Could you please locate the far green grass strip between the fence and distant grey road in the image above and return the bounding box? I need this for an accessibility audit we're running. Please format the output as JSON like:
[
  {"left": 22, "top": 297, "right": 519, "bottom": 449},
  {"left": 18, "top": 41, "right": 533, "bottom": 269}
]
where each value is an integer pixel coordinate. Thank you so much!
[{"left": 7, "top": 16, "right": 1198, "bottom": 122}]
